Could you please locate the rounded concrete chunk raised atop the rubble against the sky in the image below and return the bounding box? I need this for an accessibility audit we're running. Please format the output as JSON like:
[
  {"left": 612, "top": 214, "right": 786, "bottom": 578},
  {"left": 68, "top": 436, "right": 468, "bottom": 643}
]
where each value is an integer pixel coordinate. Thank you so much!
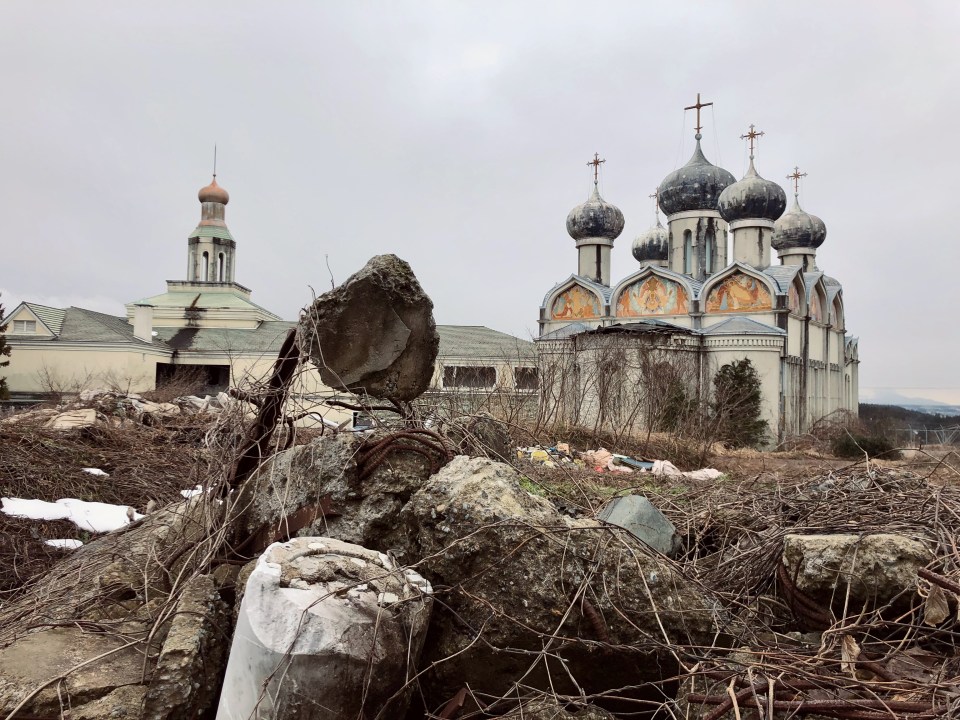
[{"left": 300, "top": 255, "right": 440, "bottom": 400}]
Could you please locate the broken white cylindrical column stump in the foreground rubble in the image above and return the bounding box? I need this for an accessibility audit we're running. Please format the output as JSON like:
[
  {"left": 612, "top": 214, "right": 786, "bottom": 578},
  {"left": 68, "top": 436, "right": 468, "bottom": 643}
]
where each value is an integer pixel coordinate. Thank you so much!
[{"left": 218, "top": 538, "right": 432, "bottom": 720}]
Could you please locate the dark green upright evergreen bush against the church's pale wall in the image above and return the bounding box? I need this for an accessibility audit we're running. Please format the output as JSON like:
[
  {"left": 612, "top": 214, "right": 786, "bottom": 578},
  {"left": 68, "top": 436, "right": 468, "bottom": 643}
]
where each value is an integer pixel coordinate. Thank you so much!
[{"left": 711, "top": 358, "right": 768, "bottom": 447}]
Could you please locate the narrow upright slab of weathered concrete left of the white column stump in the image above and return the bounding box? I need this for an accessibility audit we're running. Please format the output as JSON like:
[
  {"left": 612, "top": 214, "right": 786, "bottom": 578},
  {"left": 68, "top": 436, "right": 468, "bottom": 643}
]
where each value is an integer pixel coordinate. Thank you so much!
[{"left": 143, "top": 575, "right": 230, "bottom": 720}]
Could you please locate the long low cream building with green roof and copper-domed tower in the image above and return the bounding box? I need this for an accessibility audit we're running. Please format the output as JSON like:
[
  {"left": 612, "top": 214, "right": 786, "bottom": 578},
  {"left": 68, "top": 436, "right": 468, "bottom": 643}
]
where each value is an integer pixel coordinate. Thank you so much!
[{"left": 3, "top": 177, "right": 535, "bottom": 424}]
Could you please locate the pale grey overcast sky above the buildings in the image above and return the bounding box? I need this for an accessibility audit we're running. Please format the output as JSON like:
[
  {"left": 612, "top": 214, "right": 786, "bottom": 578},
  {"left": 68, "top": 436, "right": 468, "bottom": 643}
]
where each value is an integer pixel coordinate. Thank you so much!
[{"left": 0, "top": 0, "right": 960, "bottom": 403}]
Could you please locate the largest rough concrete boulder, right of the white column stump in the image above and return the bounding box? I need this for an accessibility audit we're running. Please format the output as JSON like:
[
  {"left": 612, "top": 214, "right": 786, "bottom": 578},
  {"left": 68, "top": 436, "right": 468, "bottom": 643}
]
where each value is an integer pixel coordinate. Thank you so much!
[{"left": 401, "top": 456, "right": 721, "bottom": 711}]
